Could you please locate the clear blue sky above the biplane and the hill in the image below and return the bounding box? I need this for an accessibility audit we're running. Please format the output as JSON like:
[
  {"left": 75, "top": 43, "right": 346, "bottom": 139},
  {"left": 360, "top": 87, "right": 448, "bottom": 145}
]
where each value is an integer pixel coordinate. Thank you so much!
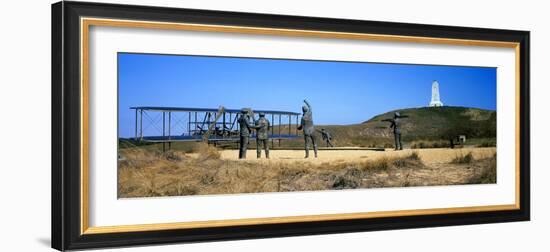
[{"left": 118, "top": 53, "right": 496, "bottom": 137}]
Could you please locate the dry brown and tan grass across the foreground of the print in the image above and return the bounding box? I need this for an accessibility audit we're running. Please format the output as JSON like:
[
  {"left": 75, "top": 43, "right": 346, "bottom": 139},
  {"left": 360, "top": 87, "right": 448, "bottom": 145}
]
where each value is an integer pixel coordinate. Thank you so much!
[{"left": 118, "top": 147, "right": 496, "bottom": 198}]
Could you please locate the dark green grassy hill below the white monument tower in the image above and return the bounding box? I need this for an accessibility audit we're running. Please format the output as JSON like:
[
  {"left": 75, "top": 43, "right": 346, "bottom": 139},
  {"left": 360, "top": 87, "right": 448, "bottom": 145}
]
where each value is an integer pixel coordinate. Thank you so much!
[{"left": 317, "top": 106, "right": 496, "bottom": 147}]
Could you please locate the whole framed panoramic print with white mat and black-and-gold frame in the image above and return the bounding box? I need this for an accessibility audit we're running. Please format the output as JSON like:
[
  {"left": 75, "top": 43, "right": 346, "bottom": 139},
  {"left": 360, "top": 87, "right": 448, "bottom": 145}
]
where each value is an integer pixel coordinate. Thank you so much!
[{"left": 52, "top": 1, "right": 530, "bottom": 250}]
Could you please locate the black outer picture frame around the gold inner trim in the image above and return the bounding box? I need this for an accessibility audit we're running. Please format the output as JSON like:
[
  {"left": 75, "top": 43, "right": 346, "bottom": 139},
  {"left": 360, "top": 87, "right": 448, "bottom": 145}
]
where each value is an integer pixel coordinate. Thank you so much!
[{"left": 51, "top": 1, "right": 530, "bottom": 250}]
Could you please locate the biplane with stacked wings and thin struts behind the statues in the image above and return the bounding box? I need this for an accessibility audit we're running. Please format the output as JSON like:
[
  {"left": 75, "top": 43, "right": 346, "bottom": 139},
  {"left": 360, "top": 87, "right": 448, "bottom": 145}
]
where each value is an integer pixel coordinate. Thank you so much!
[{"left": 130, "top": 106, "right": 300, "bottom": 143}]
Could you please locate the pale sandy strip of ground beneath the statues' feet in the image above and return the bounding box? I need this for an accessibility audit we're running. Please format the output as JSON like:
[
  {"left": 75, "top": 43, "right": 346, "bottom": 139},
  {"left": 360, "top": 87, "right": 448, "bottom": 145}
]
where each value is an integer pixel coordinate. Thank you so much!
[{"left": 220, "top": 147, "right": 496, "bottom": 164}]
